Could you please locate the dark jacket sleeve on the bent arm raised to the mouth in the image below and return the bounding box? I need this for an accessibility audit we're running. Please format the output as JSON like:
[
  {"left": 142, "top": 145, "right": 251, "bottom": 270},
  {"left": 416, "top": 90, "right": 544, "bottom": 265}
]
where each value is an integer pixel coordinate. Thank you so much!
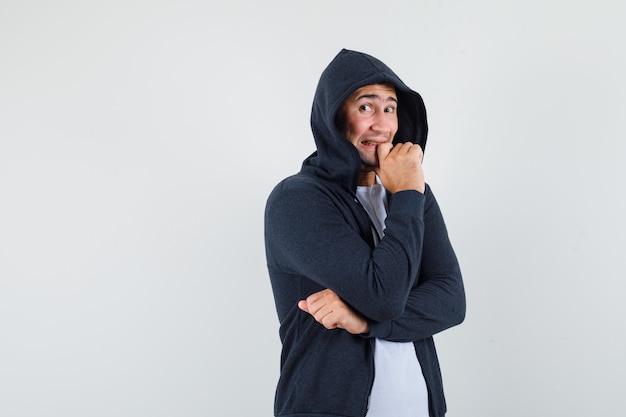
[{"left": 265, "top": 176, "right": 425, "bottom": 322}]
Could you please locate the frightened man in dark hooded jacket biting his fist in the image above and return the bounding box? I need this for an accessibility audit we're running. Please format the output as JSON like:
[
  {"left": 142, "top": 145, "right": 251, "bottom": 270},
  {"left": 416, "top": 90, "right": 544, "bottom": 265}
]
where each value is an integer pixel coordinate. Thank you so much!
[{"left": 265, "top": 49, "right": 465, "bottom": 417}]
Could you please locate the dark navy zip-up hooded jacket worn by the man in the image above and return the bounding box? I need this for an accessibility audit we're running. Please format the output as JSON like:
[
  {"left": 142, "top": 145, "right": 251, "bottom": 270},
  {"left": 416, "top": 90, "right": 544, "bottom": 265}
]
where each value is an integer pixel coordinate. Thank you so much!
[{"left": 265, "top": 49, "right": 465, "bottom": 417}]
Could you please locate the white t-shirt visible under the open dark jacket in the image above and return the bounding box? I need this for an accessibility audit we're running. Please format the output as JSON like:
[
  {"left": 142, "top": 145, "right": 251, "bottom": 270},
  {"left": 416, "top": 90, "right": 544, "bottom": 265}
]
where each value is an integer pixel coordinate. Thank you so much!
[{"left": 357, "top": 182, "right": 428, "bottom": 417}]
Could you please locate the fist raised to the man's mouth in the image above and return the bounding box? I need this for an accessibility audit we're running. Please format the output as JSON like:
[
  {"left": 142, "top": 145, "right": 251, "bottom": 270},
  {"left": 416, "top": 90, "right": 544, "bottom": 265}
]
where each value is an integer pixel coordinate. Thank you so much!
[{"left": 376, "top": 142, "right": 426, "bottom": 194}]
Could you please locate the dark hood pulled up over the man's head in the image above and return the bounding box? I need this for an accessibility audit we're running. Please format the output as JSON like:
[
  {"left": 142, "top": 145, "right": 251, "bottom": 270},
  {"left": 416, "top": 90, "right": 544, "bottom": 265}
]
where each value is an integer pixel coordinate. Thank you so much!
[{"left": 302, "top": 49, "right": 428, "bottom": 192}]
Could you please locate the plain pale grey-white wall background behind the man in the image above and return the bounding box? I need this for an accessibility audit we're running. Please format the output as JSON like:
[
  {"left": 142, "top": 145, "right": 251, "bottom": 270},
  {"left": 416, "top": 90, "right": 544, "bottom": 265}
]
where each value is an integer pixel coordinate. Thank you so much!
[{"left": 0, "top": 0, "right": 626, "bottom": 417}]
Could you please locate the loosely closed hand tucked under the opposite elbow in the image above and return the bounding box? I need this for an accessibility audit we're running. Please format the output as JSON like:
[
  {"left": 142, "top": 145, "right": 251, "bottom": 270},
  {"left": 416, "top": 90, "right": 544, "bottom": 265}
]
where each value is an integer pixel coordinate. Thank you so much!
[{"left": 298, "top": 289, "right": 369, "bottom": 334}]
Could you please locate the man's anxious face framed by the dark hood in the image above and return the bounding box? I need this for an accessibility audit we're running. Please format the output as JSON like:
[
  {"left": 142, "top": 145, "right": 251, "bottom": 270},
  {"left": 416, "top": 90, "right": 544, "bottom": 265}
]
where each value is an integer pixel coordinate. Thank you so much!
[{"left": 338, "top": 84, "right": 398, "bottom": 167}]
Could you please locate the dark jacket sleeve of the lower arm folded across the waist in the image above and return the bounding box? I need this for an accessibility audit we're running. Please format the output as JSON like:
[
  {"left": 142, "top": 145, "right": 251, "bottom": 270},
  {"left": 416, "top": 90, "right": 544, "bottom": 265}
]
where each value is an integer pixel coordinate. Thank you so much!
[{"left": 365, "top": 185, "right": 466, "bottom": 342}]
